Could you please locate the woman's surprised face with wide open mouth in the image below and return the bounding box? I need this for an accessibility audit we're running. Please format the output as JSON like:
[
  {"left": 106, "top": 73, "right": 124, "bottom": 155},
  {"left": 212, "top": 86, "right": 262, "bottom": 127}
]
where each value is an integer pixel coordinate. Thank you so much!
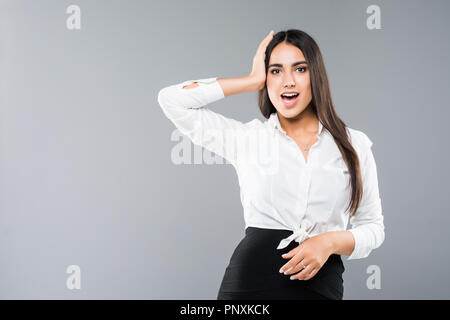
[{"left": 267, "top": 42, "right": 312, "bottom": 118}]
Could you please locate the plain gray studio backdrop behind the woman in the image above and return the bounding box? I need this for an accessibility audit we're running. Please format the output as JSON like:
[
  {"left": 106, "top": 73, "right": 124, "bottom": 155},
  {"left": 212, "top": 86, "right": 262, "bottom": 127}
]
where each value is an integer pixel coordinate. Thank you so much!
[{"left": 0, "top": 0, "right": 450, "bottom": 299}]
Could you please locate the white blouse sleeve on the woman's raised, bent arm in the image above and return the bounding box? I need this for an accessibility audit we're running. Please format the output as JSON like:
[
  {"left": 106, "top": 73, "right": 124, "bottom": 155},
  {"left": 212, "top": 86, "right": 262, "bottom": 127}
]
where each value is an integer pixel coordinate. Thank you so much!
[{"left": 158, "top": 78, "right": 245, "bottom": 166}]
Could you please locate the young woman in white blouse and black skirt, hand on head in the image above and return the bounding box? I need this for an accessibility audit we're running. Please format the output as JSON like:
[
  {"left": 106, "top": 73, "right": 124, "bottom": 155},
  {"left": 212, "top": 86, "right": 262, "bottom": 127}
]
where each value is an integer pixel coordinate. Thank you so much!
[{"left": 158, "top": 29, "right": 384, "bottom": 299}]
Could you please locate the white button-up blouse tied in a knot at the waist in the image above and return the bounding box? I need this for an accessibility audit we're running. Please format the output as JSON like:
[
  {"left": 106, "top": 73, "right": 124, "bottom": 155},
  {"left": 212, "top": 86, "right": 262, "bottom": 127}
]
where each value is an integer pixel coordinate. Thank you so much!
[{"left": 158, "top": 78, "right": 384, "bottom": 260}]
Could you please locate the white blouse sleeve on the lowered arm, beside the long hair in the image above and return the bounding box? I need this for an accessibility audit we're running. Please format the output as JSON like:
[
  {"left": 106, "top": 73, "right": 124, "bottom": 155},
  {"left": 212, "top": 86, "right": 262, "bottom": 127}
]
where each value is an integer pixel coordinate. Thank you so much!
[{"left": 347, "top": 132, "right": 384, "bottom": 260}]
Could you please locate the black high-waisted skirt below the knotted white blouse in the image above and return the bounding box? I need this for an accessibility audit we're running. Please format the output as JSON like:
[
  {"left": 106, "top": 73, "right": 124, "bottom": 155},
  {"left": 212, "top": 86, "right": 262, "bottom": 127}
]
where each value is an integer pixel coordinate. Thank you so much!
[{"left": 217, "top": 227, "right": 345, "bottom": 300}]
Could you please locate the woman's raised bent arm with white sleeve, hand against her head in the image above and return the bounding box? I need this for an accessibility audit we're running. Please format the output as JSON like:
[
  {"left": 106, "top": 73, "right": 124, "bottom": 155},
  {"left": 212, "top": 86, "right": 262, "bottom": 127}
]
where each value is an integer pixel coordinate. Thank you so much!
[{"left": 158, "top": 33, "right": 273, "bottom": 165}]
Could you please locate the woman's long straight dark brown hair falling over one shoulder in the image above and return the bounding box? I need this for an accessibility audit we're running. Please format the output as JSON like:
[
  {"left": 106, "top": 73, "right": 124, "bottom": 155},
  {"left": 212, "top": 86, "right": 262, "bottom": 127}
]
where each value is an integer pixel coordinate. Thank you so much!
[{"left": 258, "top": 29, "right": 363, "bottom": 216}]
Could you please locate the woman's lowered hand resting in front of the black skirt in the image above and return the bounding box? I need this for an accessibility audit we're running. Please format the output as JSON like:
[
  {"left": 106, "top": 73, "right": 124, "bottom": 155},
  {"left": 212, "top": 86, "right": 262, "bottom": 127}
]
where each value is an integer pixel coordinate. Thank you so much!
[{"left": 280, "top": 233, "right": 332, "bottom": 280}]
